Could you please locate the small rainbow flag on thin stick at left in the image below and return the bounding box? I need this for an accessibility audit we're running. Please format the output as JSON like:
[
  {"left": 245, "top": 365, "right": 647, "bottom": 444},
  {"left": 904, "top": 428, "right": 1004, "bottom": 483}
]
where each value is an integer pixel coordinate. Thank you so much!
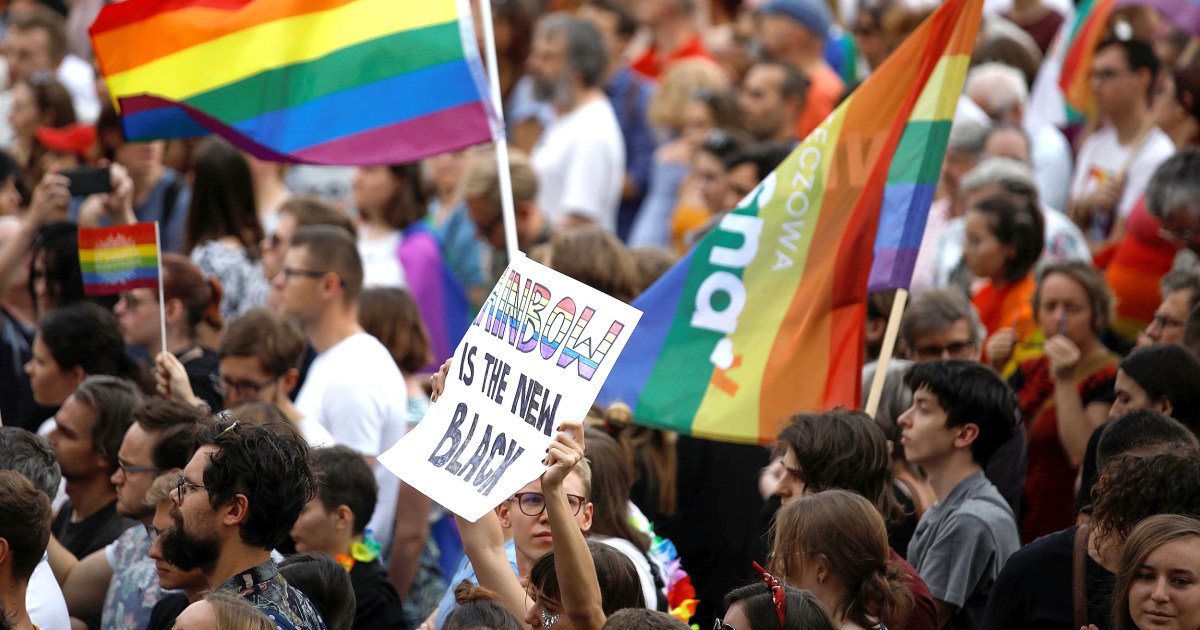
[{"left": 79, "top": 223, "right": 160, "bottom": 295}]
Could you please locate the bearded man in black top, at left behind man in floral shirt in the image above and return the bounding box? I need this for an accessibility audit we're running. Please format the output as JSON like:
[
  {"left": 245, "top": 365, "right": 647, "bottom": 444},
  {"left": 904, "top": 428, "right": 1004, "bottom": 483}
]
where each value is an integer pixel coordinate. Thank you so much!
[{"left": 49, "top": 376, "right": 142, "bottom": 558}]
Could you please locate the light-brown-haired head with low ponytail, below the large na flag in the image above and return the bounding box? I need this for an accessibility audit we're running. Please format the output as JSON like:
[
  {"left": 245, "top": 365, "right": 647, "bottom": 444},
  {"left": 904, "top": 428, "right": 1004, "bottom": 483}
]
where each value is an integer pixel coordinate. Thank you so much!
[{"left": 756, "top": 490, "right": 913, "bottom": 630}]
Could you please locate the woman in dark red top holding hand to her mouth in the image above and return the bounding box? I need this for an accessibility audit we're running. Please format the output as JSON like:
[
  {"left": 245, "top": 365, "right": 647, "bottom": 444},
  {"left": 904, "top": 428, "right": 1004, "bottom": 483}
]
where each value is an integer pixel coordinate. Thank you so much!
[{"left": 1008, "top": 262, "right": 1120, "bottom": 542}]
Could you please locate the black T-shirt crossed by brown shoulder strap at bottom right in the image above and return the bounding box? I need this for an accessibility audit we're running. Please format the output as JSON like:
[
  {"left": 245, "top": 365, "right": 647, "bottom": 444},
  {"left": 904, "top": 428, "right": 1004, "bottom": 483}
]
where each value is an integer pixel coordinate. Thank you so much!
[{"left": 983, "top": 526, "right": 1114, "bottom": 630}]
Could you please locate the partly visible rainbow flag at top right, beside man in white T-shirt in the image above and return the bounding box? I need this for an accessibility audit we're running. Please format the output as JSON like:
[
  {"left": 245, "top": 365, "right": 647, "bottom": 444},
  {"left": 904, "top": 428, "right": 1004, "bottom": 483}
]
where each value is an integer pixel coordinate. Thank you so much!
[{"left": 1058, "top": 0, "right": 1113, "bottom": 124}]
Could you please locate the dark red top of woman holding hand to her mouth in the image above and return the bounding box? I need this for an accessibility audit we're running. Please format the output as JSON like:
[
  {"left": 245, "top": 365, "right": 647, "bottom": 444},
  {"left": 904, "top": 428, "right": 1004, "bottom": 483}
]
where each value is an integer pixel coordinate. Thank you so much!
[{"left": 1009, "top": 353, "right": 1120, "bottom": 544}]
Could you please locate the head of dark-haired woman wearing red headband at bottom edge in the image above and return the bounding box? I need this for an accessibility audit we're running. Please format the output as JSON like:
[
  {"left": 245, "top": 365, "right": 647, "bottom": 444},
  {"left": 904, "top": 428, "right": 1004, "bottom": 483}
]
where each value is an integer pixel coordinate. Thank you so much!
[{"left": 713, "top": 563, "right": 838, "bottom": 630}]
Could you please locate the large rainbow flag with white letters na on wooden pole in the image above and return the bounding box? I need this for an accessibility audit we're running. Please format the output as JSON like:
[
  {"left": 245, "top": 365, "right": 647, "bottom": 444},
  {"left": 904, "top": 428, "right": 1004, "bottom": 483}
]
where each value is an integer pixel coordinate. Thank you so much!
[{"left": 599, "top": 0, "right": 983, "bottom": 443}]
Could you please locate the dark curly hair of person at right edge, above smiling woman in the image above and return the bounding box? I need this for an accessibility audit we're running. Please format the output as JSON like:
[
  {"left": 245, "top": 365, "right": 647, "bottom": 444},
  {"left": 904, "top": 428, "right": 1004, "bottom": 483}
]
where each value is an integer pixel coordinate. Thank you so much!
[{"left": 1092, "top": 445, "right": 1200, "bottom": 541}]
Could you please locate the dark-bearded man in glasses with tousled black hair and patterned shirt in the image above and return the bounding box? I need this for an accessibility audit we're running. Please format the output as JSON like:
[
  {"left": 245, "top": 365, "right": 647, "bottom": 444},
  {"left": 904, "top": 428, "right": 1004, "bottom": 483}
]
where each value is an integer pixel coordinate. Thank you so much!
[{"left": 160, "top": 421, "right": 325, "bottom": 630}]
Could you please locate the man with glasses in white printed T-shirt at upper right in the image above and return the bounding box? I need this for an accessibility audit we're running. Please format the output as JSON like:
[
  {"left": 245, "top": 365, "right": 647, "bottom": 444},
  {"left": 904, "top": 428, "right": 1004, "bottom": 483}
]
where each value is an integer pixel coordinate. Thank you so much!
[{"left": 1067, "top": 38, "right": 1175, "bottom": 252}]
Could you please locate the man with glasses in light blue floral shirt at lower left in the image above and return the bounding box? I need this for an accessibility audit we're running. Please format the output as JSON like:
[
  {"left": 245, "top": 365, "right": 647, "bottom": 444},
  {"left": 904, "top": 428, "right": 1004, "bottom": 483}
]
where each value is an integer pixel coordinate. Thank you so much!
[{"left": 49, "top": 398, "right": 204, "bottom": 630}]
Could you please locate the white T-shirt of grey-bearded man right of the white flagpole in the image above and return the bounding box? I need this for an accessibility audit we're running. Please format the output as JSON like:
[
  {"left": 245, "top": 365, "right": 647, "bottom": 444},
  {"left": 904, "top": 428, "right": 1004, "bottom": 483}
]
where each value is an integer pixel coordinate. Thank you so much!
[{"left": 532, "top": 98, "right": 625, "bottom": 230}]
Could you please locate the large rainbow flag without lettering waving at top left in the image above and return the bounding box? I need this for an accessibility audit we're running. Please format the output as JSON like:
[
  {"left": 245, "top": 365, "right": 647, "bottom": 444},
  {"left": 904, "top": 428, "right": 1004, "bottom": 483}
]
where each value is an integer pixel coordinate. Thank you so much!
[{"left": 90, "top": 0, "right": 500, "bottom": 166}]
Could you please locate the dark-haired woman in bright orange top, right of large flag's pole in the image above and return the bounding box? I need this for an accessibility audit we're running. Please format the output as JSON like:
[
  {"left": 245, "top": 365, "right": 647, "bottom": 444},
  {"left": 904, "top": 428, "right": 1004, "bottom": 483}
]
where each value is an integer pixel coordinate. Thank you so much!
[{"left": 962, "top": 196, "right": 1045, "bottom": 373}]
